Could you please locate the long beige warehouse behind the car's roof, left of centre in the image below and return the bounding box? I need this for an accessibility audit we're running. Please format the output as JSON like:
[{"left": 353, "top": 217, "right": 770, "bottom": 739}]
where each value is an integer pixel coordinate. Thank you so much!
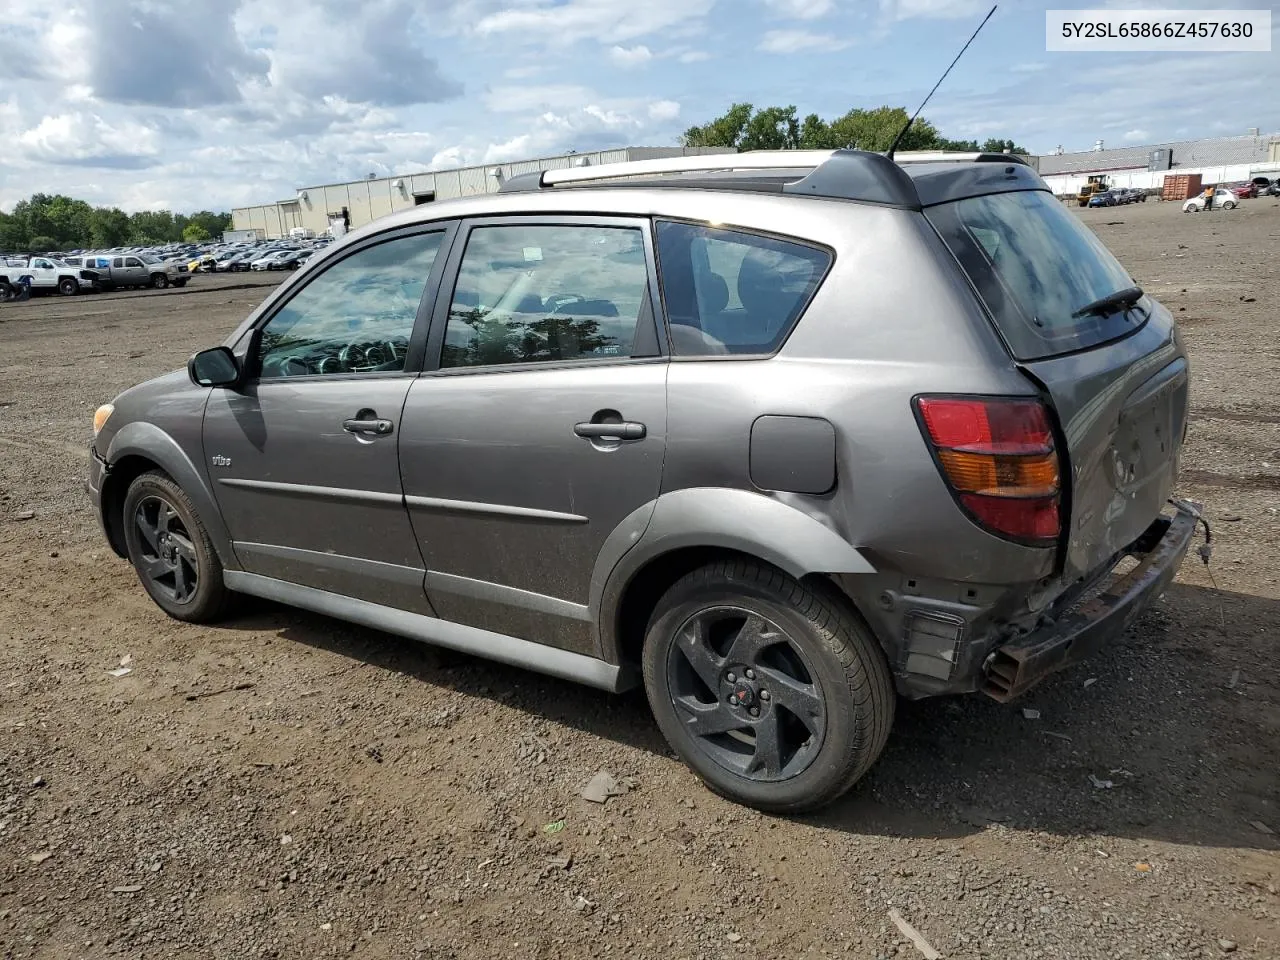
[{"left": 232, "top": 147, "right": 733, "bottom": 239}]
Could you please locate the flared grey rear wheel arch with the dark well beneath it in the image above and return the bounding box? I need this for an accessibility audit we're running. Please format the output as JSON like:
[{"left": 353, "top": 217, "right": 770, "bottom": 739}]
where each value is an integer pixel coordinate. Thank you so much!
[{"left": 589, "top": 488, "right": 876, "bottom": 664}]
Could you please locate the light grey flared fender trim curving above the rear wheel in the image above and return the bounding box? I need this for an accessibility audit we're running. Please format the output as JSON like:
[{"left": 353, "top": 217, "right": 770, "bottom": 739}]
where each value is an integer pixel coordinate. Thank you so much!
[{"left": 588, "top": 486, "right": 876, "bottom": 663}]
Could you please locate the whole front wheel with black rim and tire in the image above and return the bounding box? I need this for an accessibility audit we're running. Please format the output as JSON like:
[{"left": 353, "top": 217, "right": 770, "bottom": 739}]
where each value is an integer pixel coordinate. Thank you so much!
[{"left": 123, "top": 470, "right": 232, "bottom": 623}]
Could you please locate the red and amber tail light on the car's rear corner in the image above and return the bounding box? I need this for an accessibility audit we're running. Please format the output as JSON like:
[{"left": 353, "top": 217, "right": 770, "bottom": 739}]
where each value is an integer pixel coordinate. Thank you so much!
[{"left": 915, "top": 397, "right": 1062, "bottom": 545}]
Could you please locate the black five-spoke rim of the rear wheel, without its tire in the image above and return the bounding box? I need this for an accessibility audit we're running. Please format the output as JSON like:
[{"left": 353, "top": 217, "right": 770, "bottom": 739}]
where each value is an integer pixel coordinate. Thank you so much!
[{"left": 667, "top": 605, "right": 827, "bottom": 781}]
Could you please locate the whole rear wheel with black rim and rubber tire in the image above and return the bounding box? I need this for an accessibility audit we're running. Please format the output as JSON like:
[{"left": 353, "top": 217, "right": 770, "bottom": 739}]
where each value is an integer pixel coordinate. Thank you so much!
[{"left": 644, "top": 561, "right": 895, "bottom": 814}]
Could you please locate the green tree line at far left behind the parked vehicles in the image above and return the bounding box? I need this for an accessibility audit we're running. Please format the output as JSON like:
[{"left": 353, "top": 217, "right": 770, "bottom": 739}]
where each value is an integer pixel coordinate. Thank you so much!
[{"left": 0, "top": 193, "right": 232, "bottom": 253}]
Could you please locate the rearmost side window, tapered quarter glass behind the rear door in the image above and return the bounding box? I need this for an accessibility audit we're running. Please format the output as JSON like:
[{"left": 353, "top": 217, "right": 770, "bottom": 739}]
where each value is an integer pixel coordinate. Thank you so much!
[{"left": 658, "top": 220, "right": 831, "bottom": 356}]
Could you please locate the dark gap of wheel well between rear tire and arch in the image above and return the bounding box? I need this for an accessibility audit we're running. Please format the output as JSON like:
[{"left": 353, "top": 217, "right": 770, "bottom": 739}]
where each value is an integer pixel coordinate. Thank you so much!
[{"left": 604, "top": 547, "right": 876, "bottom": 666}]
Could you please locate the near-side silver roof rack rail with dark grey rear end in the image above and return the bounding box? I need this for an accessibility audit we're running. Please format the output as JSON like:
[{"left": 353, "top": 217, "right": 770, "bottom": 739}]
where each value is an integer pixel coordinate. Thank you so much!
[{"left": 498, "top": 150, "right": 920, "bottom": 209}]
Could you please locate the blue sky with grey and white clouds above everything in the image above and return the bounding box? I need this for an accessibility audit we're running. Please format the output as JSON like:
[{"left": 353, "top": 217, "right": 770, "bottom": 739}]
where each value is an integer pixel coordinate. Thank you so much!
[{"left": 0, "top": 0, "right": 1280, "bottom": 211}]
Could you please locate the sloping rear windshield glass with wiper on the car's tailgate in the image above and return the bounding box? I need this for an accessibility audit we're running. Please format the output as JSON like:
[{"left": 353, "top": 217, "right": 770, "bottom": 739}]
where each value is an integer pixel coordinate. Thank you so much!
[{"left": 925, "top": 191, "right": 1148, "bottom": 360}]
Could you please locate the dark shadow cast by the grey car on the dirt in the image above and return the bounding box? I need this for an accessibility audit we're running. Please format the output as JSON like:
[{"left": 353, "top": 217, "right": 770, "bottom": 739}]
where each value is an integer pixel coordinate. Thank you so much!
[{"left": 215, "top": 584, "right": 1280, "bottom": 850}]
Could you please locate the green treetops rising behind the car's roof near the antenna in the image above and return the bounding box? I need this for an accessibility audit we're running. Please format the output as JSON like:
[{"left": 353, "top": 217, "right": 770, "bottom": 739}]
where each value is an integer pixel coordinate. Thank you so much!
[{"left": 680, "top": 104, "right": 1028, "bottom": 155}]
